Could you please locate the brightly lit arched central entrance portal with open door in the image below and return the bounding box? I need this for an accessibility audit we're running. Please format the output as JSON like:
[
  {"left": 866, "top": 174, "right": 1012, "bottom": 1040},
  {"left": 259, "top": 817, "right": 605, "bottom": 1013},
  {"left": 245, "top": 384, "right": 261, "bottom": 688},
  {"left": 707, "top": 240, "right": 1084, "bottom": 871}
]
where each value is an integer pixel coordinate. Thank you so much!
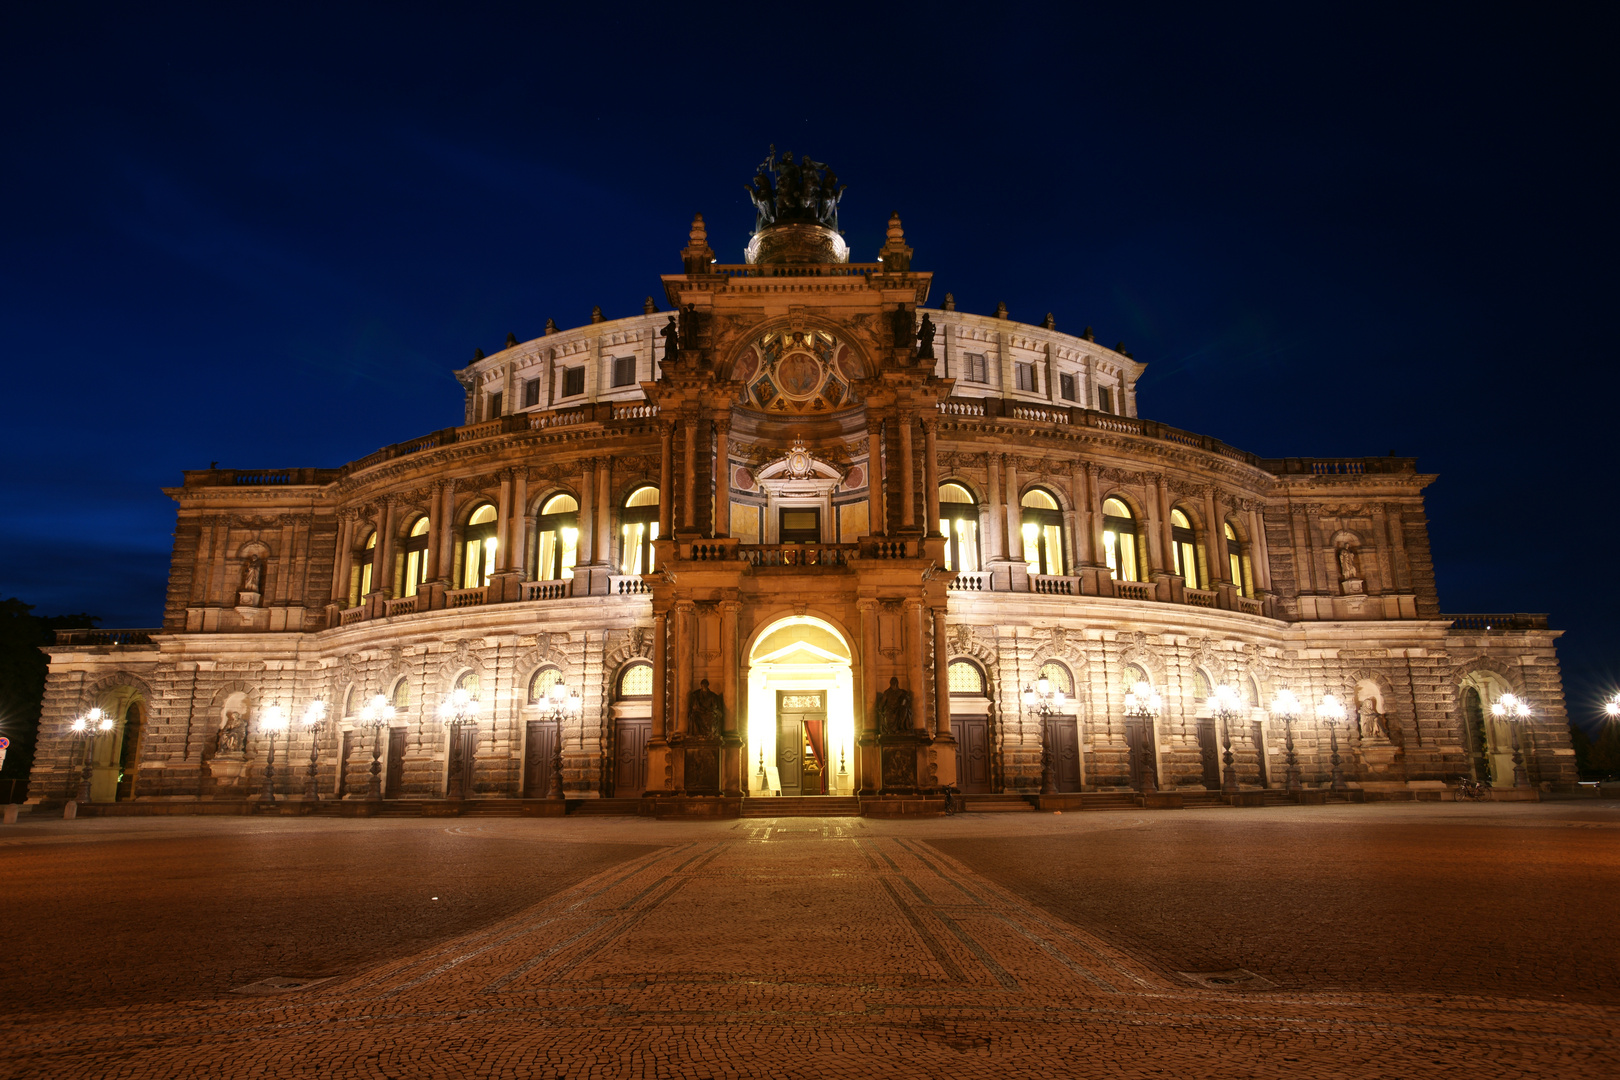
[{"left": 747, "top": 615, "right": 855, "bottom": 795}]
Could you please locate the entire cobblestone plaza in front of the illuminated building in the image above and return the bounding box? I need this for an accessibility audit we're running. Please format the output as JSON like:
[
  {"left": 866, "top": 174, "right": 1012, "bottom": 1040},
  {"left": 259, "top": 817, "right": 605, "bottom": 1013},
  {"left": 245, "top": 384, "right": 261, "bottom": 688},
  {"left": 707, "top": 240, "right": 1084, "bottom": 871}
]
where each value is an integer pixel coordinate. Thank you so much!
[{"left": 0, "top": 800, "right": 1620, "bottom": 1077}]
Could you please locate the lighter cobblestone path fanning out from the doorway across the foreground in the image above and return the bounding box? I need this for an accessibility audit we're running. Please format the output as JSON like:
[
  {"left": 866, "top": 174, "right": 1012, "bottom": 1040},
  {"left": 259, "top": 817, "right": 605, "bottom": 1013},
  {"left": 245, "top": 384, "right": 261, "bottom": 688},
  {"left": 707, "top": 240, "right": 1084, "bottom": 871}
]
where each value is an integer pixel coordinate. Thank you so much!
[{"left": 0, "top": 808, "right": 1620, "bottom": 1077}]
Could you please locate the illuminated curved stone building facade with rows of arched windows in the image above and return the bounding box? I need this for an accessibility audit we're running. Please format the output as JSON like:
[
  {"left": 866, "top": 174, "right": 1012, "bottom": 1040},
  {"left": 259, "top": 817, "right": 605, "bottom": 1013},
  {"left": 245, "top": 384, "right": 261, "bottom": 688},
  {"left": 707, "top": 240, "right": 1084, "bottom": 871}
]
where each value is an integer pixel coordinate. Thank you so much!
[{"left": 31, "top": 200, "right": 1575, "bottom": 803}]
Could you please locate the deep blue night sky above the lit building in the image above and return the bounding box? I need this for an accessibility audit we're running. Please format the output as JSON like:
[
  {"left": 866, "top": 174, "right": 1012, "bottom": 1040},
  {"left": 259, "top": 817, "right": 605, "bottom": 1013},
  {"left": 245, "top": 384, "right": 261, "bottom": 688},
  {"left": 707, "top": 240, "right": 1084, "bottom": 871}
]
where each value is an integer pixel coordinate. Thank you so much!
[{"left": 0, "top": 3, "right": 1620, "bottom": 717}]
